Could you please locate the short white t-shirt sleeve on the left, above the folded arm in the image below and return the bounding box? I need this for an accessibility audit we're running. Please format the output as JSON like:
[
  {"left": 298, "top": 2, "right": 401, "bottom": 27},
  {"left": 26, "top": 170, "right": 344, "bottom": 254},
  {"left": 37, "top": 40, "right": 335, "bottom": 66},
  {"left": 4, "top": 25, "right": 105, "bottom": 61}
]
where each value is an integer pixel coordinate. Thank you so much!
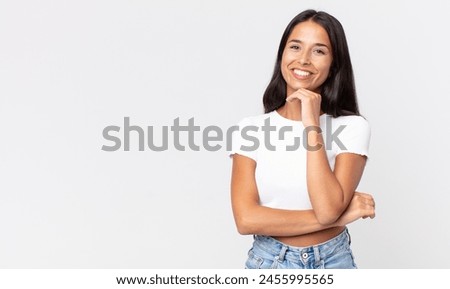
[{"left": 228, "top": 117, "right": 259, "bottom": 161}]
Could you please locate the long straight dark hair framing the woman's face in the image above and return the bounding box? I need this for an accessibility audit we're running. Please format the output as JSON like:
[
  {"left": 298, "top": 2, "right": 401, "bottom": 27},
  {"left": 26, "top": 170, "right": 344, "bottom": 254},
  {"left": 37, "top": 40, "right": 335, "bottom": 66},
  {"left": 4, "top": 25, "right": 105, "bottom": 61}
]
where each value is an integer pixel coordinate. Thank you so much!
[{"left": 263, "top": 10, "right": 359, "bottom": 117}]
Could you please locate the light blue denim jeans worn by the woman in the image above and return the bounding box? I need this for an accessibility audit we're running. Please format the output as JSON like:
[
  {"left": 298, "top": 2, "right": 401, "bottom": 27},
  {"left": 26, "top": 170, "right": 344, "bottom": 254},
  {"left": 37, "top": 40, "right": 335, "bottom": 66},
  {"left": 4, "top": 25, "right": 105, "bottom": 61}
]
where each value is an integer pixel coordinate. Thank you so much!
[{"left": 245, "top": 228, "right": 357, "bottom": 269}]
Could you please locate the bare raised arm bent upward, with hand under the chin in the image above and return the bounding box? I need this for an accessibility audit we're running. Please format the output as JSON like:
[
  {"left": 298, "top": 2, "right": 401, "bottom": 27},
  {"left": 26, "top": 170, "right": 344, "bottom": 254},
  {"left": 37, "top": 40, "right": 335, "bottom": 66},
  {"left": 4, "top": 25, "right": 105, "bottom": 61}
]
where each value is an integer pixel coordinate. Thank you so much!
[{"left": 286, "top": 88, "right": 366, "bottom": 225}]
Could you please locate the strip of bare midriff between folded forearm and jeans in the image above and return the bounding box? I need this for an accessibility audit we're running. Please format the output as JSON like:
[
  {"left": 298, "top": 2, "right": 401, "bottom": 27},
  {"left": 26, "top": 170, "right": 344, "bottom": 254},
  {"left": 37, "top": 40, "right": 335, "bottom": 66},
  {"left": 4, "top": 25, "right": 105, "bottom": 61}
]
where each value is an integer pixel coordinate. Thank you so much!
[{"left": 273, "top": 227, "right": 345, "bottom": 247}]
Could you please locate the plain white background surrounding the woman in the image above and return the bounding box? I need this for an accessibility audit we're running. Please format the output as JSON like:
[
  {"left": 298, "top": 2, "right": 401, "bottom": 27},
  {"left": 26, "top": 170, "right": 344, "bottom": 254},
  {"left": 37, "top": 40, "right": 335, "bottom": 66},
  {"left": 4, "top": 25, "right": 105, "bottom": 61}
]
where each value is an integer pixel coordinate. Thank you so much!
[{"left": 0, "top": 0, "right": 450, "bottom": 268}]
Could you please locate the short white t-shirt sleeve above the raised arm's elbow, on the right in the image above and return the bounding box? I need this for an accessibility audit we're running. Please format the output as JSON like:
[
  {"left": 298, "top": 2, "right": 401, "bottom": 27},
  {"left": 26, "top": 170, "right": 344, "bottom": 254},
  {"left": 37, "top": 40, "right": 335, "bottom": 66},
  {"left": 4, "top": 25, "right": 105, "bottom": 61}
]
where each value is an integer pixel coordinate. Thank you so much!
[{"left": 336, "top": 116, "right": 371, "bottom": 157}]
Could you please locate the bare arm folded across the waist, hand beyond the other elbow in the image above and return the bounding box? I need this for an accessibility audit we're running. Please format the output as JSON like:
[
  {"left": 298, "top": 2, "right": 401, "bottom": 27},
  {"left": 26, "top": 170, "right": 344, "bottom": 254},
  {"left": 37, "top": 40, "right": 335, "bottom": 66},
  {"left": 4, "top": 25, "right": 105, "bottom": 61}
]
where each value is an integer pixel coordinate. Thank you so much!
[{"left": 231, "top": 154, "right": 374, "bottom": 236}]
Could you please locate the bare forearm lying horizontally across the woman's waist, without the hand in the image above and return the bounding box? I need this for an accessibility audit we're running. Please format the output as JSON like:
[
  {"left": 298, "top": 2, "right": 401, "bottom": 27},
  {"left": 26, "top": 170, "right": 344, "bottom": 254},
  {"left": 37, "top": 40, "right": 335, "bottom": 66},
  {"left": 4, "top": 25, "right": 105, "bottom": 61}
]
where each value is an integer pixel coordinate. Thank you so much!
[{"left": 235, "top": 205, "right": 336, "bottom": 236}]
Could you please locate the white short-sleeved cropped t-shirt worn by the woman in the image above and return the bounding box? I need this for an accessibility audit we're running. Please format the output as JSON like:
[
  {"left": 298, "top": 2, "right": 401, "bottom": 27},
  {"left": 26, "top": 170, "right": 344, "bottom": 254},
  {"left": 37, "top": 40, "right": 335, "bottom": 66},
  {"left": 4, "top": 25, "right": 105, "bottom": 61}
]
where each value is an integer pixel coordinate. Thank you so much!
[{"left": 229, "top": 110, "right": 370, "bottom": 210}]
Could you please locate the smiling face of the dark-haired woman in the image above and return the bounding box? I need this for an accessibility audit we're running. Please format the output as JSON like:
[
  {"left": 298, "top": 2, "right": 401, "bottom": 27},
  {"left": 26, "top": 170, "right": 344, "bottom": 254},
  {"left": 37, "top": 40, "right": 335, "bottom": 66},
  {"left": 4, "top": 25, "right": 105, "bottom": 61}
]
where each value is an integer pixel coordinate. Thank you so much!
[{"left": 281, "top": 21, "right": 333, "bottom": 95}]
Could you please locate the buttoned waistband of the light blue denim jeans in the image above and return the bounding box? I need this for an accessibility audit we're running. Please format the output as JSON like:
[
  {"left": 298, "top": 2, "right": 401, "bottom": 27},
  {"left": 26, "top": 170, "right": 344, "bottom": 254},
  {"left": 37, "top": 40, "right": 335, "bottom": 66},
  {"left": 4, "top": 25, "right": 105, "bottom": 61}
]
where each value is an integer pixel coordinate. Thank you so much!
[{"left": 253, "top": 228, "right": 350, "bottom": 263}]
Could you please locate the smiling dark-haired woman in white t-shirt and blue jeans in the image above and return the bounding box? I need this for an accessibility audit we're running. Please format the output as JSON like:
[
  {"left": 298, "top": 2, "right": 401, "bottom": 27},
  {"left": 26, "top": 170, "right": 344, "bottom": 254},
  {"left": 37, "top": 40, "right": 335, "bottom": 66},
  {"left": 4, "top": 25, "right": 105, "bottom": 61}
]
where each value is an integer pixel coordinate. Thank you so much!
[{"left": 230, "top": 10, "right": 375, "bottom": 269}]
